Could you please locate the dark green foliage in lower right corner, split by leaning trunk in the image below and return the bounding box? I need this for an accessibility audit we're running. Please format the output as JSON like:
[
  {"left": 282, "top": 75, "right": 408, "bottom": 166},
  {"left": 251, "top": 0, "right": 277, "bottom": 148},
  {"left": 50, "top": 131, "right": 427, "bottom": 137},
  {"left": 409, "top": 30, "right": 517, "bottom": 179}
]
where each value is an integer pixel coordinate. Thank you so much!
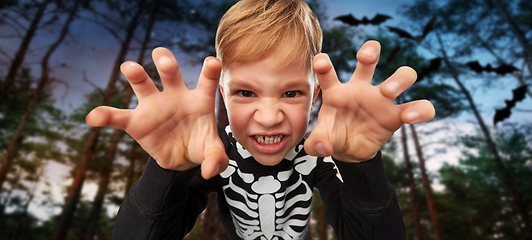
[{"left": 440, "top": 125, "right": 532, "bottom": 239}]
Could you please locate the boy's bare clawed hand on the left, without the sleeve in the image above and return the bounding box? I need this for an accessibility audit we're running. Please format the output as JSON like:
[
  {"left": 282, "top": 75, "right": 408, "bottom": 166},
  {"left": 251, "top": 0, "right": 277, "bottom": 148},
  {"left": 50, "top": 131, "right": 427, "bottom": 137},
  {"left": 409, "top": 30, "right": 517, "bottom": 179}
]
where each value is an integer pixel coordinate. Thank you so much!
[{"left": 86, "top": 48, "right": 228, "bottom": 179}]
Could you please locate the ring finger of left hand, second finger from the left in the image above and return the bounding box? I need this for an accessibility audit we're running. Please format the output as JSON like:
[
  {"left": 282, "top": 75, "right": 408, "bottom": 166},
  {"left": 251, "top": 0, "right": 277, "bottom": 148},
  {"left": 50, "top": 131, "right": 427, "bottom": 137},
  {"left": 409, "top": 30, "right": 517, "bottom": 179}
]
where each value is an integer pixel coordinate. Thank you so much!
[{"left": 120, "top": 62, "right": 159, "bottom": 101}]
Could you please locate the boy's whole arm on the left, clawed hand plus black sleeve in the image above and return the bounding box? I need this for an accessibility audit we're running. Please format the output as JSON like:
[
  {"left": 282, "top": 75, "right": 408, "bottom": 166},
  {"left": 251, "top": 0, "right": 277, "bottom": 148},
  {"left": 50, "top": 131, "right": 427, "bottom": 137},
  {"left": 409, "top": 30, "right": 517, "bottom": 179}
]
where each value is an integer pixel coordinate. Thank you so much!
[{"left": 86, "top": 48, "right": 228, "bottom": 239}]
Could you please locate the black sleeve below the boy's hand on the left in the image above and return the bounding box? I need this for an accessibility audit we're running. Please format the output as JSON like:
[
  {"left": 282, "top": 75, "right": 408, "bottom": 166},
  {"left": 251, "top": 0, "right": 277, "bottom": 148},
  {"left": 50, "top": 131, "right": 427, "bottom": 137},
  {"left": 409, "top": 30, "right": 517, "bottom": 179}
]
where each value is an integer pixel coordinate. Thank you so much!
[{"left": 113, "top": 158, "right": 214, "bottom": 239}]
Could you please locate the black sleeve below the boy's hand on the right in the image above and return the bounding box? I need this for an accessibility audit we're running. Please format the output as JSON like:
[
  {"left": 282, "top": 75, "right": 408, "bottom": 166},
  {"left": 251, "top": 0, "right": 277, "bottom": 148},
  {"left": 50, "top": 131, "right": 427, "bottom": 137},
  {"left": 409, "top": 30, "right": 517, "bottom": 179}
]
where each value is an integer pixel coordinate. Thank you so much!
[{"left": 316, "top": 152, "right": 406, "bottom": 240}]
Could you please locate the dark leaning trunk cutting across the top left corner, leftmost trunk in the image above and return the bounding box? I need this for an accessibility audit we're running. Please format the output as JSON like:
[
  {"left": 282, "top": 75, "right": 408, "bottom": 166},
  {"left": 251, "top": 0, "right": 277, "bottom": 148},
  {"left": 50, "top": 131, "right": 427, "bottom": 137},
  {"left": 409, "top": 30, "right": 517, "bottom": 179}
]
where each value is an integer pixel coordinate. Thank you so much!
[{"left": 0, "top": 0, "right": 50, "bottom": 106}]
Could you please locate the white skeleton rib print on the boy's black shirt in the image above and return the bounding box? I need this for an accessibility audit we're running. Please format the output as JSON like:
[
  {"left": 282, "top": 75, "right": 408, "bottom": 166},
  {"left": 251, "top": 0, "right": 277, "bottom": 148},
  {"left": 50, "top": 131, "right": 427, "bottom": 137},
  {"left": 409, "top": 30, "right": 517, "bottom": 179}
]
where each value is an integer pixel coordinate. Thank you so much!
[{"left": 220, "top": 129, "right": 317, "bottom": 240}]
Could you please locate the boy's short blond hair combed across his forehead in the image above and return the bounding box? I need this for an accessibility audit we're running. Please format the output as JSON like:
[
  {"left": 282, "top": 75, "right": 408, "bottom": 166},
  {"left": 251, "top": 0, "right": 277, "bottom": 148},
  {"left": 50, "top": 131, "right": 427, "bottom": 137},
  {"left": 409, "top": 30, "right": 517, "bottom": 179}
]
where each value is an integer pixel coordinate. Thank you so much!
[{"left": 216, "top": 0, "right": 322, "bottom": 72}]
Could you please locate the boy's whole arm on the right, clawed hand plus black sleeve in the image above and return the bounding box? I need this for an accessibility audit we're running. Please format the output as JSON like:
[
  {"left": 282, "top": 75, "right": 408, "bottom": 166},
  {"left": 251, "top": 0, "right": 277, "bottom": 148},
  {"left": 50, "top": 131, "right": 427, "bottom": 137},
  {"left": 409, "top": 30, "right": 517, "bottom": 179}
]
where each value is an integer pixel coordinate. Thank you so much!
[{"left": 305, "top": 41, "right": 435, "bottom": 239}]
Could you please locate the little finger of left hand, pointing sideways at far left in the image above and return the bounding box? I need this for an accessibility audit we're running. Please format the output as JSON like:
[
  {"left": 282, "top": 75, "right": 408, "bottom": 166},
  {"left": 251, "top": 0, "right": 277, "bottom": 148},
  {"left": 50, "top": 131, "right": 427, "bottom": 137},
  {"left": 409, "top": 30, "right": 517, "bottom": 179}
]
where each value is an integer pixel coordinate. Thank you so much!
[{"left": 85, "top": 106, "right": 131, "bottom": 129}]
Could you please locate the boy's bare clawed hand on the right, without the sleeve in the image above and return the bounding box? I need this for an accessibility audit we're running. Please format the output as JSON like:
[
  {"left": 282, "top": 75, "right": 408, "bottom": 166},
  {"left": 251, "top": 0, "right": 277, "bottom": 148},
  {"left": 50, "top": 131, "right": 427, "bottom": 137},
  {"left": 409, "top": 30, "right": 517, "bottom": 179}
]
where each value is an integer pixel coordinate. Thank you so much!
[{"left": 305, "top": 41, "right": 435, "bottom": 162}]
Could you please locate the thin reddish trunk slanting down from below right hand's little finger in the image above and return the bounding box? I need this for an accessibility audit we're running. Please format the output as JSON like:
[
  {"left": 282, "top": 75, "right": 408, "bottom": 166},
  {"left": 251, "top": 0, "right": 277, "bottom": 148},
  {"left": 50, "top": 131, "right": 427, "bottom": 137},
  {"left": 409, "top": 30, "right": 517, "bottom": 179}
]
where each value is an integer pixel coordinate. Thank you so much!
[{"left": 410, "top": 125, "right": 443, "bottom": 240}]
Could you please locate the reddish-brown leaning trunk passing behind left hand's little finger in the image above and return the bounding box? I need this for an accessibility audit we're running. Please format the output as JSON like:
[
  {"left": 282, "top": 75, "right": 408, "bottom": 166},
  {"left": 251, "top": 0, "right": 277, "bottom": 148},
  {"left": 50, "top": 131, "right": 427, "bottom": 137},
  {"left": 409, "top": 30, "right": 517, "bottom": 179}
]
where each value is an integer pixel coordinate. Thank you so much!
[{"left": 53, "top": 0, "right": 146, "bottom": 240}]
